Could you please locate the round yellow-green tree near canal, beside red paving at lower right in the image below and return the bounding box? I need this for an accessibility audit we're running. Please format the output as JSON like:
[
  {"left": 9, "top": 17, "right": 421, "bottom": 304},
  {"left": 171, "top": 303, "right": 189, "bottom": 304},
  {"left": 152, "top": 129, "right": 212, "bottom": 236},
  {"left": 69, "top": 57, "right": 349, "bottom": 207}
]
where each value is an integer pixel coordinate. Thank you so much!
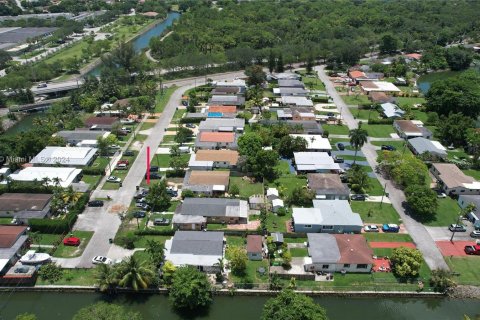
[{"left": 390, "top": 247, "right": 423, "bottom": 278}]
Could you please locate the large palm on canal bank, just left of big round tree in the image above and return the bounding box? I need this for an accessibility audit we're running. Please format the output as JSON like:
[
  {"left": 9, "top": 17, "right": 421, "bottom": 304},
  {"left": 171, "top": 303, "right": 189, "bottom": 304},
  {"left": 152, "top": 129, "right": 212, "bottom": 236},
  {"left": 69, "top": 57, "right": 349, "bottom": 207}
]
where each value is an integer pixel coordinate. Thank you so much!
[{"left": 118, "top": 256, "right": 155, "bottom": 291}]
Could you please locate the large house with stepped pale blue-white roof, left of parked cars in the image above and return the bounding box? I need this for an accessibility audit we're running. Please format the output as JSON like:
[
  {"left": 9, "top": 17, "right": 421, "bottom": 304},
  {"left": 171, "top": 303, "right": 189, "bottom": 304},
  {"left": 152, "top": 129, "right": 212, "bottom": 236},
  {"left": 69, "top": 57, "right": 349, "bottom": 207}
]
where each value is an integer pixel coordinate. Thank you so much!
[{"left": 292, "top": 200, "right": 363, "bottom": 233}]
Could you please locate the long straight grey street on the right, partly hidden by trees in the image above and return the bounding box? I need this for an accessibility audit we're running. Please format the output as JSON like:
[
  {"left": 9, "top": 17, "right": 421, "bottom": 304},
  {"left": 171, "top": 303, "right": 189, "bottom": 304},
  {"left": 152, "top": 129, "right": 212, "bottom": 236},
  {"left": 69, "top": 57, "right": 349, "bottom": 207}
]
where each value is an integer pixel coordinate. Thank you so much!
[{"left": 314, "top": 66, "right": 448, "bottom": 270}]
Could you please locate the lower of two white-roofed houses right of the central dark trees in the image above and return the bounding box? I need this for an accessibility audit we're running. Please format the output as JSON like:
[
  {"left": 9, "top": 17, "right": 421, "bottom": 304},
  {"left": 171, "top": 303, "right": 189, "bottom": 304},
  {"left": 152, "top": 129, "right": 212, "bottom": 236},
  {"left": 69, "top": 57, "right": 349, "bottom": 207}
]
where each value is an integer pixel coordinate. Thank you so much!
[{"left": 293, "top": 152, "right": 342, "bottom": 172}]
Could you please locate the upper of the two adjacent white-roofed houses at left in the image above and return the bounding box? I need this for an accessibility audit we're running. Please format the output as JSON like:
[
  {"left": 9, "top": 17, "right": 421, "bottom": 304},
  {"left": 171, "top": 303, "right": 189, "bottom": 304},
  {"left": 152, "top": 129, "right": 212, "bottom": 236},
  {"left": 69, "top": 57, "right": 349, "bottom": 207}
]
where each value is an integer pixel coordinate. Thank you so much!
[{"left": 30, "top": 147, "right": 97, "bottom": 166}]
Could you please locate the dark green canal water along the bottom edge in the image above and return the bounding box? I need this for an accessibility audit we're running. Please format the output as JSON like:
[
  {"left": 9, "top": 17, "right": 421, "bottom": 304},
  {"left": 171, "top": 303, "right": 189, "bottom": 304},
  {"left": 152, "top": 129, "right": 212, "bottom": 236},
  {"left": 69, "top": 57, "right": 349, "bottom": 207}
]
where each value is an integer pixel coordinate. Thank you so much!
[{"left": 0, "top": 292, "right": 480, "bottom": 320}]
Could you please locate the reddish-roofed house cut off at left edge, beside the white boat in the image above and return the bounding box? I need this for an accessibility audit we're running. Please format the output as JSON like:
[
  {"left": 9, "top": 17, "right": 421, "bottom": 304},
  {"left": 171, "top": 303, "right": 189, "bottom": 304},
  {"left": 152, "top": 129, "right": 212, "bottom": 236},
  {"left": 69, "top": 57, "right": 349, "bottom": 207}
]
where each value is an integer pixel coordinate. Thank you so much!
[{"left": 0, "top": 225, "right": 28, "bottom": 275}]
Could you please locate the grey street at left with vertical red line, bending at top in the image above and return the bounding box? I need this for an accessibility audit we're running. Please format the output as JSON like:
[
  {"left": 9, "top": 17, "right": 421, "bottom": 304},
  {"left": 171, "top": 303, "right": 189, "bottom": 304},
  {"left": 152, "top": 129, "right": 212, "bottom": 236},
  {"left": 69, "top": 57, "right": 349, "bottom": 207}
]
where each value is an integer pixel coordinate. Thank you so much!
[{"left": 55, "top": 72, "right": 244, "bottom": 268}]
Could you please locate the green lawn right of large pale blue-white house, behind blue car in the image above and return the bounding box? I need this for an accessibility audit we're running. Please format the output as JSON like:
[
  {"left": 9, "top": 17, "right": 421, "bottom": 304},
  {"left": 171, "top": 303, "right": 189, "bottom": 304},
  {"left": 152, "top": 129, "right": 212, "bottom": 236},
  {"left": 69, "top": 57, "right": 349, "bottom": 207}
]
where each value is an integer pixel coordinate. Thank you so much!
[{"left": 351, "top": 201, "right": 400, "bottom": 224}]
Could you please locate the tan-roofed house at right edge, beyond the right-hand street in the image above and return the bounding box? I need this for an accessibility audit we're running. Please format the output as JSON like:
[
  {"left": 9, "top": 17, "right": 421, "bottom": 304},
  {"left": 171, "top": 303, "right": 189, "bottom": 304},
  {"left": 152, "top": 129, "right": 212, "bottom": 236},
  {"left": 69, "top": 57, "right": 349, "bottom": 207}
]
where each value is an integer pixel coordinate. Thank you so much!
[{"left": 430, "top": 163, "right": 480, "bottom": 195}]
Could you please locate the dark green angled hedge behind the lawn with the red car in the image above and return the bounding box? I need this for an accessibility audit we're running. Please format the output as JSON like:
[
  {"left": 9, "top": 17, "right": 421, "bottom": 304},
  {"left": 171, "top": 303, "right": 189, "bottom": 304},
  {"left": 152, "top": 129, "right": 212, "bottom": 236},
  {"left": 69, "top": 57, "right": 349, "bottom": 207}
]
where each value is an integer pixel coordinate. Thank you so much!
[{"left": 28, "top": 193, "right": 89, "bottom": 234}]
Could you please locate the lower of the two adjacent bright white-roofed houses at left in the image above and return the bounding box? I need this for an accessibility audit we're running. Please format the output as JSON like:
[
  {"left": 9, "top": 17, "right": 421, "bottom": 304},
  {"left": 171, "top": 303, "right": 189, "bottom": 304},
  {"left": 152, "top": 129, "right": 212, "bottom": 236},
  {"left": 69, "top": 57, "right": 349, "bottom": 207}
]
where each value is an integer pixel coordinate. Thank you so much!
[{"left": 10, "top": 167, "right": 82, "bottom": 188}]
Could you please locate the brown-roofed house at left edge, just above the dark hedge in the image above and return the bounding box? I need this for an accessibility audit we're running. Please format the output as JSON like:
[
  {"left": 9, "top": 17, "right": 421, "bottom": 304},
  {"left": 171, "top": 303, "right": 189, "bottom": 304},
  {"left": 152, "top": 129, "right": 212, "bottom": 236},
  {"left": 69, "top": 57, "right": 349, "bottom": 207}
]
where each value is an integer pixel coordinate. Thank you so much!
[{"left": 0, "top": 193, "right": 53, "bottom": 224}]
